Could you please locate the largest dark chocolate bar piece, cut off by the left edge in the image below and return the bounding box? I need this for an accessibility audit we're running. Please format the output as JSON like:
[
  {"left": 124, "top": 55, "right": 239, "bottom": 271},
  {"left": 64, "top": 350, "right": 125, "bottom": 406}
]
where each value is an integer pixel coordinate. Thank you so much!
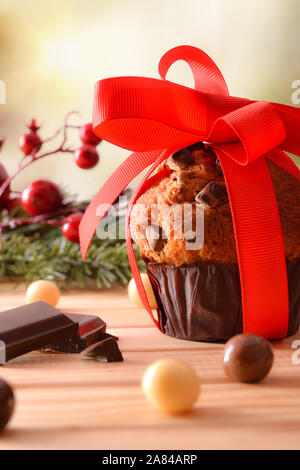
[{"left": 0, "top": 301, "right": 78, "bottom": 364}]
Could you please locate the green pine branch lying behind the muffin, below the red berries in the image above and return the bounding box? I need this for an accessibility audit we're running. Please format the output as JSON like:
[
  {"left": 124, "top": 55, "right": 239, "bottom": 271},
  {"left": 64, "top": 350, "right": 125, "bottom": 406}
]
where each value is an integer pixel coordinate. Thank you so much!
[{"left": 0, "top": 224, "right": 144, "bottom": 288}]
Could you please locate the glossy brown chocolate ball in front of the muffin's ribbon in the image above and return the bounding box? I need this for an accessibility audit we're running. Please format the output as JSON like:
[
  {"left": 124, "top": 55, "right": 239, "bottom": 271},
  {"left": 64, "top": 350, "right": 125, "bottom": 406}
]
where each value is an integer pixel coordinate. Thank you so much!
[{"left": 223, "top": 334, "right": 274, "bottom": 383}]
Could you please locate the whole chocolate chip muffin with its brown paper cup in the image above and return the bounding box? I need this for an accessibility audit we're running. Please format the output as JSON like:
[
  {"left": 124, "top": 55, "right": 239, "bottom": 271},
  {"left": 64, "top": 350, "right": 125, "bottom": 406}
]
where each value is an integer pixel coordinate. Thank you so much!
[{"left": 130, "top": 142, "right": 300, "bottom": 341}]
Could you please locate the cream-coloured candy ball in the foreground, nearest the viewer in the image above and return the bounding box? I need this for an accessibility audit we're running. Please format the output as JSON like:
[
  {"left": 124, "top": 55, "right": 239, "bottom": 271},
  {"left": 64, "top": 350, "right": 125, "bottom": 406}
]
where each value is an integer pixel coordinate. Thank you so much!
[{"left": 142, "top": 359, "right": 200, "bottom": 414}]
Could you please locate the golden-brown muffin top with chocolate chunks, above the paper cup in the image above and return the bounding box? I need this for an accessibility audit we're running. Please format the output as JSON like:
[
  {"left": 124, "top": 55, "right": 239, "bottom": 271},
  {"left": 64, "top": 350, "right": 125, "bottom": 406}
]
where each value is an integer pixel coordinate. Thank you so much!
[{"left": 130, "top": 142, "right": 300, "bottom": 266}]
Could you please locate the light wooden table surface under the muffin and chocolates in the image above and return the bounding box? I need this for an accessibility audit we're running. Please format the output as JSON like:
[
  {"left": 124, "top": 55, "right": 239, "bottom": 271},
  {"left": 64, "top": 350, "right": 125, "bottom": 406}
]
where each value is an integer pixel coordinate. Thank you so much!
[{"left": 0, "top": 284, "right": 300, "bottom": 449}]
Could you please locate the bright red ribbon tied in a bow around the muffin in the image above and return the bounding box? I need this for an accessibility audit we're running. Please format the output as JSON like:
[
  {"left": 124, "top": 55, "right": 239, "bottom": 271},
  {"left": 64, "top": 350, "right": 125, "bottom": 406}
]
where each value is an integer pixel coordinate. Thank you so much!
[{"left": 80, "top": 46, "right": 300, "bottom": 339}]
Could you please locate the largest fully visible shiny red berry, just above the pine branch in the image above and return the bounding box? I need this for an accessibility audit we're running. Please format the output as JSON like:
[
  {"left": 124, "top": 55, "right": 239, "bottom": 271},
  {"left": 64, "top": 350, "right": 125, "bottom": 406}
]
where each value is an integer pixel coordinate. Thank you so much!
[{"left": 21, "top": 180, "right": 62, "bottom": 216}]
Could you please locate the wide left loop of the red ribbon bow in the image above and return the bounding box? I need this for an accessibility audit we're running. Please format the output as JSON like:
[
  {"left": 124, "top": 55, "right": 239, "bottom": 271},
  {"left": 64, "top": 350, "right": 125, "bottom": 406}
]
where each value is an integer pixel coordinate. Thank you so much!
[{"left": 93, "top": 77, "right": 207, "bottom": 152}]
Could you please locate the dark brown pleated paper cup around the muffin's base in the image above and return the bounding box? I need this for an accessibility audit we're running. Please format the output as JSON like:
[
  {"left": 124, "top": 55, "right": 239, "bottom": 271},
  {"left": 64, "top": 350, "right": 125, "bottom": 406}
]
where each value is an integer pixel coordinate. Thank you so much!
[{"left": 147, "top": 260, "right": 300, "bottom": 342}]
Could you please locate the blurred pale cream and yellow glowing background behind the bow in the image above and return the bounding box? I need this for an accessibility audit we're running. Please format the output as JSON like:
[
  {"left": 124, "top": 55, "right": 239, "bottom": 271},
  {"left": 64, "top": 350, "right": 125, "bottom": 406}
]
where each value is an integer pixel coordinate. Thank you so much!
[{"left": 0, "top": 0, "right": 300, "bottom": 198}]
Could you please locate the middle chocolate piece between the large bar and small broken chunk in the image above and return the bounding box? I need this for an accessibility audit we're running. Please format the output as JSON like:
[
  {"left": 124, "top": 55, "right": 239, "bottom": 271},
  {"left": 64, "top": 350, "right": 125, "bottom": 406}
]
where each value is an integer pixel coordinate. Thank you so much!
[{"left": 43, "top": 313, "right": 106, "bottom": 354}]
